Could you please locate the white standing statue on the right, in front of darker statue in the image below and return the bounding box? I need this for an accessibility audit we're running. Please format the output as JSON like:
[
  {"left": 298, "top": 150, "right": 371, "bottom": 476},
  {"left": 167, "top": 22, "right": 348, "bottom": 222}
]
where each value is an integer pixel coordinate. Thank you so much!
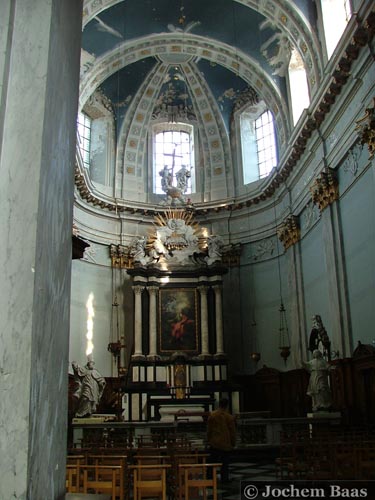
[{"left": 303, "top": 349, "right": 332, "bottom": 412}]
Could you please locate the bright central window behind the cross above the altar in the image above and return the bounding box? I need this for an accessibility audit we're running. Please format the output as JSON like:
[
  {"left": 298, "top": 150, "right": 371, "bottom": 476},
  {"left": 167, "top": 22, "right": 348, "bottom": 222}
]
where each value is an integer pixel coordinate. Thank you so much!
[{"left": 153, "top": 123, "right": 195, "bottom": 194}]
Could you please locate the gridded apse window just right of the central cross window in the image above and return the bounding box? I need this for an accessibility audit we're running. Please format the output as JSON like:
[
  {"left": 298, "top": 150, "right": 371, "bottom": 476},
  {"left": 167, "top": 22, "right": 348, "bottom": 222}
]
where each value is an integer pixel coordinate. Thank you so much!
[{"left": 240, "top": 107, "right": 277, "bottom": 184}]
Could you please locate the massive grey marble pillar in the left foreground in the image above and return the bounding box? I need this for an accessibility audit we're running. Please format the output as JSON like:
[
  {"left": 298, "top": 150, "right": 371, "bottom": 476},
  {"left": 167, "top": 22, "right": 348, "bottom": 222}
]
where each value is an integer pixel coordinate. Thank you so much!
[{"left": 0, "top": 0, "right": 82, "bottom": 500}]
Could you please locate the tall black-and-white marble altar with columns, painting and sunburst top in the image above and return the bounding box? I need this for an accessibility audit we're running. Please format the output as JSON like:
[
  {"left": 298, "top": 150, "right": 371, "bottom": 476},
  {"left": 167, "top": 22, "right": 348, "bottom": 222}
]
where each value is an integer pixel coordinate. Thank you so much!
[{"left": 124, "top": 209, "right": 239, "bottom": 422}]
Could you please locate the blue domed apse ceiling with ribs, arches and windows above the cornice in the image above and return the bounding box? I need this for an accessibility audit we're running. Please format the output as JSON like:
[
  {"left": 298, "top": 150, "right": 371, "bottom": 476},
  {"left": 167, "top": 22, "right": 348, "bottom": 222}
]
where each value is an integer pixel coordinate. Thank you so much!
[{"left": 76, "top": 0, "right": 324, "bottom": 219}]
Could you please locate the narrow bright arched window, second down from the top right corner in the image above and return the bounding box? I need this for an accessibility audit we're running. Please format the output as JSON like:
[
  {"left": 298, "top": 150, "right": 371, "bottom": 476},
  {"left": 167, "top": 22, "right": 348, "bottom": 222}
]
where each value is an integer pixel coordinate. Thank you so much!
[{"left": 288, "top": 48, "right": 310, "bottom": 125}]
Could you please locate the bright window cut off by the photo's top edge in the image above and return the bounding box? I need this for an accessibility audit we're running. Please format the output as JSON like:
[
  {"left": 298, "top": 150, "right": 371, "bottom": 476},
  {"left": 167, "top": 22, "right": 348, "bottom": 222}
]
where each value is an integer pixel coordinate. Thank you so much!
[{"left": 321, "top": 0, "right": 352, "bottom": 59}]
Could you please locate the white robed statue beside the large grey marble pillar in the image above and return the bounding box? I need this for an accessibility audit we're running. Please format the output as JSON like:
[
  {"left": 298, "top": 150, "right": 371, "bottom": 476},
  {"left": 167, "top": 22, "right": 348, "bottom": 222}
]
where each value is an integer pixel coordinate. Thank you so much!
[{"left": 72, "top": 360, "right": 106, "bottom": 417}]
